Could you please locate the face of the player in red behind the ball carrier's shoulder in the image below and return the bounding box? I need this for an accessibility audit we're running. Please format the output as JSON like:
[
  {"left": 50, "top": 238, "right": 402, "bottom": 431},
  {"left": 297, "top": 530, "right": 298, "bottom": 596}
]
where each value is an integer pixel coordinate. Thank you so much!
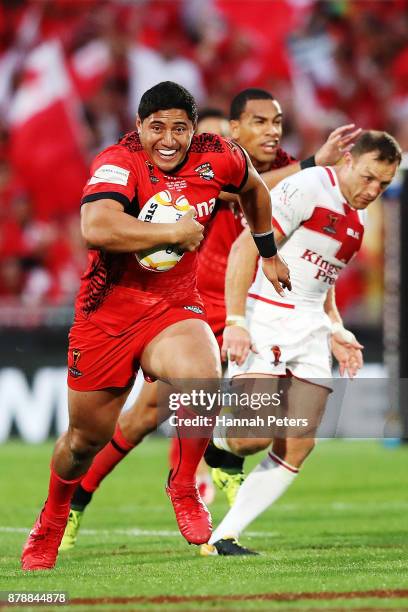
[{"left": 231, "top": 100, "right": 282, "bottom": 169}]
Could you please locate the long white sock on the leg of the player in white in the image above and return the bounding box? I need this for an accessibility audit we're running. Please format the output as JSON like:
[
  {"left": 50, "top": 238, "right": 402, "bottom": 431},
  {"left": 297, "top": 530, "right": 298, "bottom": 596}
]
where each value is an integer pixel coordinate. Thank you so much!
[{"left": 210, "top": 451, "right": 299, "bottom": 544}]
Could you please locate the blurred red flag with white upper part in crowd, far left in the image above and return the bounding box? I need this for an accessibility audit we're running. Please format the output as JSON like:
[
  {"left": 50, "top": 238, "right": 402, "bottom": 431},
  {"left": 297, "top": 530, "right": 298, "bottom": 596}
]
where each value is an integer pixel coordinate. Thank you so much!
[{"left": 10, "top": 40, "right": 87, "bottom": 219}]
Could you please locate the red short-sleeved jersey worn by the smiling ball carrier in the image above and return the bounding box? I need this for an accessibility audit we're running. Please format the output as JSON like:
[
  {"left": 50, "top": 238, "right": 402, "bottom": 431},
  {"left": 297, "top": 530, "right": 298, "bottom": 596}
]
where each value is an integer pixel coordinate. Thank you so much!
[{"left": 75, "top": 132, "right": 248, "bottom": 334}]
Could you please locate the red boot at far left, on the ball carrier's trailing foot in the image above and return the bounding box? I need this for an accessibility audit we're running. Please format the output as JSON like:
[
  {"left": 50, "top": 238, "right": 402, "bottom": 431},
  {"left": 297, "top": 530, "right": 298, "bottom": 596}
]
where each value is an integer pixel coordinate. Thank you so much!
[{"left": 21, "top": 510, "right": 68, "bottom": 571}]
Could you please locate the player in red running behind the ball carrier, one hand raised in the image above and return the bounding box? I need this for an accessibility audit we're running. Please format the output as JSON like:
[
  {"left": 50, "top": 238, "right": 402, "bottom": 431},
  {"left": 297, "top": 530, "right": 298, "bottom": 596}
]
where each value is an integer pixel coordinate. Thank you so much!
[{"left": 57, "top": 89, "right": 360, "bottom": 550}]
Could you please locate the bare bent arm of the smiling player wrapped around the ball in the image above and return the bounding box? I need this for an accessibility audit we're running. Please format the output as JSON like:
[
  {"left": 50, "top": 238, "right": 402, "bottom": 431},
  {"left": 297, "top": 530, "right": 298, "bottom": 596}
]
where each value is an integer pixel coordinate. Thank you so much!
[{"left": 81, "top": 199, "right": 204, "bottom": 253}]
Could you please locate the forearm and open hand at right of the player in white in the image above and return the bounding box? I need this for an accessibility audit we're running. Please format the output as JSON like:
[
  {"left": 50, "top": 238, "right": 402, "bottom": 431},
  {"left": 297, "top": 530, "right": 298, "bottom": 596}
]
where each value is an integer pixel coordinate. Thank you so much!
[{"left": 324, "top": 287, "right": 364, "bottom": 378}]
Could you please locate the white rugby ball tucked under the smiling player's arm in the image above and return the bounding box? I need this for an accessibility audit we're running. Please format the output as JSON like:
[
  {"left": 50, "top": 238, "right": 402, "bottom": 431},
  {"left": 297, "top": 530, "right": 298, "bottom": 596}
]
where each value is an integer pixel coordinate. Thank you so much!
[{"left": 136, "top": 191, "right": 191, "bottom": 272}]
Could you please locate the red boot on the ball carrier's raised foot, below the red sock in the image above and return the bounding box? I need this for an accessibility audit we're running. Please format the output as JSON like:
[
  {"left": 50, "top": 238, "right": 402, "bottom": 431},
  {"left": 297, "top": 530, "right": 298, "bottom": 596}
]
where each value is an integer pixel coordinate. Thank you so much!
[{"left": 166, "top": 472, "right": 212, "bottom": 545}]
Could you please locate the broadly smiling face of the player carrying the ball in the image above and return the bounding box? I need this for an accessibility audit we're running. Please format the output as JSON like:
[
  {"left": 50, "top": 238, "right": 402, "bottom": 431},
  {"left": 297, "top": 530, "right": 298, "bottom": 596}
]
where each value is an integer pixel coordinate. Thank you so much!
[{"left": 136, "top": 108, "right": 195, "bottom": 172}]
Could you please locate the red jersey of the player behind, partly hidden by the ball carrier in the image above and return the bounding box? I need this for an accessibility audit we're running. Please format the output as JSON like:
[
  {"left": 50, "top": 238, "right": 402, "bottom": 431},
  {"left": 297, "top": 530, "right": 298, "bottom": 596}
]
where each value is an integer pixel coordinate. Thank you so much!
[{"left": 197, "top": 149, "right": 296, "bottom": 304}]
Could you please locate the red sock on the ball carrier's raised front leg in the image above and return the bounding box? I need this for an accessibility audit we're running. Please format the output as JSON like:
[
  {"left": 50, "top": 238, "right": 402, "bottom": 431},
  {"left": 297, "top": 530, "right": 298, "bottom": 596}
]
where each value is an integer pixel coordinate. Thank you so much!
[{"left": 171, "top": 407, "right": 213, "bottom": 484}]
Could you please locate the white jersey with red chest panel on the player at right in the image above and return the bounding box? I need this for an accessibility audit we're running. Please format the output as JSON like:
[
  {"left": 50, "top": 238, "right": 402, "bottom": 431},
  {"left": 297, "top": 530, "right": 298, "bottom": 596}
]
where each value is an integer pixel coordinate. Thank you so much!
[{"left": 248, "top": 166, "right": 366, "bottom": 310}]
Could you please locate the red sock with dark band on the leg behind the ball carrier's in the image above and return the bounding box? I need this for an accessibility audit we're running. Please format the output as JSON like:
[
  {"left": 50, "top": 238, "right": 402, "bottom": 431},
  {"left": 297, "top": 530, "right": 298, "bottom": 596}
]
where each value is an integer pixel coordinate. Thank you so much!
[{"left": 81, "top": 424, "right": 134, "bottom": 493}]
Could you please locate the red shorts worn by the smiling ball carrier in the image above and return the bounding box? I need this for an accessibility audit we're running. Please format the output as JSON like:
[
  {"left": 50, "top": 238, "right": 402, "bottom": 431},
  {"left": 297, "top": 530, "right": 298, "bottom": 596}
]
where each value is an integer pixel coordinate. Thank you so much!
[{"left": 68, "top": 305, "right": 207, "bottom": 391}]
